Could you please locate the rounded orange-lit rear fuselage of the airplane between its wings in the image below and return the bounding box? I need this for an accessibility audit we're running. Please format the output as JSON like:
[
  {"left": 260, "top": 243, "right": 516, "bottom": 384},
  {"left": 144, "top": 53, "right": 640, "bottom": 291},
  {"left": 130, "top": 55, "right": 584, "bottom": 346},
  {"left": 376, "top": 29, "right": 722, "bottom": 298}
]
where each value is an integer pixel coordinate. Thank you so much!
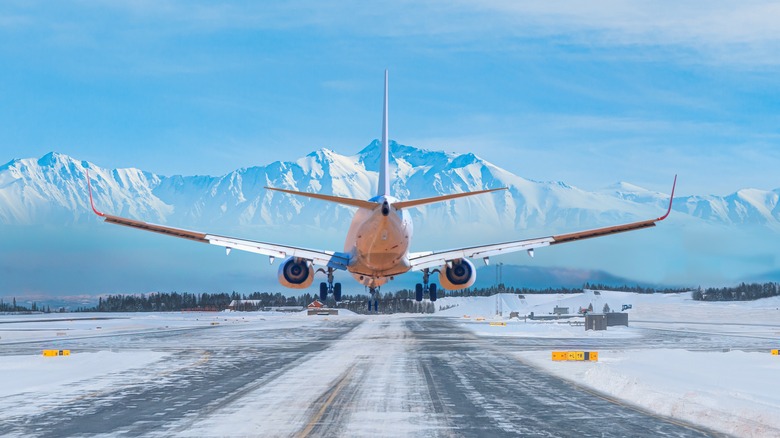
[{"left": 344, "top": 196, "right": 413, "bottom": 288}]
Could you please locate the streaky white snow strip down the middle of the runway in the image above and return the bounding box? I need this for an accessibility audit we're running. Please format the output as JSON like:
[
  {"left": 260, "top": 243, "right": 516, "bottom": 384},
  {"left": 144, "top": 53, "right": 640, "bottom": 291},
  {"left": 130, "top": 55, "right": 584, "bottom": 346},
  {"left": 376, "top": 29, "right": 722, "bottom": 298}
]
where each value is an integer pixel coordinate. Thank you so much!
[{"left": 177, "top": 317, "right": 433, "bottom": 436}]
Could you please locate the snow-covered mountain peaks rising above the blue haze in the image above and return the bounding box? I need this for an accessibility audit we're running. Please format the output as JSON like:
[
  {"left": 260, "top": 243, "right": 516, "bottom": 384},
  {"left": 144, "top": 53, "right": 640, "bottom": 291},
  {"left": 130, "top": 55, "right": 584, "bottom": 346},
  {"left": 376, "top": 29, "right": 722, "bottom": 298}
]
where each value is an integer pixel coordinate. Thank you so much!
[{"left": 0, "top": 141, "right": 780, "bottom": 232}]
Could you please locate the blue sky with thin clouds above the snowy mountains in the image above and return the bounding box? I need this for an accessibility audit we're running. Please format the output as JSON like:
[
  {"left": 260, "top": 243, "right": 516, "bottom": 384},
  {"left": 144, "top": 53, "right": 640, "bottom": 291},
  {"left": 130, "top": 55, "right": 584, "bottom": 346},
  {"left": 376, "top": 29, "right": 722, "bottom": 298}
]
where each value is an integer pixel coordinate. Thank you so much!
[{"left": 0, "top": 0, "right": 780, "bottom": 195}]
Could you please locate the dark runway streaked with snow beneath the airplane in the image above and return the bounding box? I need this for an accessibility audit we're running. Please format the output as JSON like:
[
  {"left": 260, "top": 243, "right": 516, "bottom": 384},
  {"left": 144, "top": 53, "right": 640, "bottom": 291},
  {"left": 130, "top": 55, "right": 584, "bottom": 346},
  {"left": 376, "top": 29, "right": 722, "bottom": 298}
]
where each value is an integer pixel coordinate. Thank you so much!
[{"left": 0, "top": 316, "right": 732, "bottom": 437}]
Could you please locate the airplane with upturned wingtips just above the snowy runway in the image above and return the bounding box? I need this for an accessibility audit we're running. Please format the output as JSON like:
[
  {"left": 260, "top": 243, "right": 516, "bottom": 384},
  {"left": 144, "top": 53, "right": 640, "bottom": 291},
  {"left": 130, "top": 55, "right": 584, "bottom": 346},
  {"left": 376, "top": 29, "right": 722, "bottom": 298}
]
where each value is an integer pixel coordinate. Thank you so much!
[{"left": 86, "top": 70, "right": 677, "bottom": 311}]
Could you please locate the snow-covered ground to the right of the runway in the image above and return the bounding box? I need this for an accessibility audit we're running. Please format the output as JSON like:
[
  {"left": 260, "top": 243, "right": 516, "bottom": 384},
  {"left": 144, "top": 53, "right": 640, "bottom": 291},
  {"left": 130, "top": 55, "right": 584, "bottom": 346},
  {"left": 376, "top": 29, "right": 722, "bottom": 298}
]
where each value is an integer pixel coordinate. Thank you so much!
[{"left": 444, "top": 291, "right": 780, "bottom": 437}]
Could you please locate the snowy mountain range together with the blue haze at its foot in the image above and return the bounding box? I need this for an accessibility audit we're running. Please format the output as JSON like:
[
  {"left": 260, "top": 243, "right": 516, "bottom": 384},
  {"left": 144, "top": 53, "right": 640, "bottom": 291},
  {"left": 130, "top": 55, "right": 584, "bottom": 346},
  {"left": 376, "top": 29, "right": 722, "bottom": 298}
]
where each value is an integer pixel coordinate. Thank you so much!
[{"left": 0, "top": 141, "right": 780, "bottom": 295}]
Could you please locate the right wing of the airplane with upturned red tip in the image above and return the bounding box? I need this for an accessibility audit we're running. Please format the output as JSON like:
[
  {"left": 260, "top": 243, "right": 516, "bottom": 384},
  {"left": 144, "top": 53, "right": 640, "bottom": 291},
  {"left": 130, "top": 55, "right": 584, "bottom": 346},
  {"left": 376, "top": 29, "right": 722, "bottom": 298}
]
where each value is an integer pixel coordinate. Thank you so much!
[{"left": 409, "top": 175, "right": 677, "bottom": 271}]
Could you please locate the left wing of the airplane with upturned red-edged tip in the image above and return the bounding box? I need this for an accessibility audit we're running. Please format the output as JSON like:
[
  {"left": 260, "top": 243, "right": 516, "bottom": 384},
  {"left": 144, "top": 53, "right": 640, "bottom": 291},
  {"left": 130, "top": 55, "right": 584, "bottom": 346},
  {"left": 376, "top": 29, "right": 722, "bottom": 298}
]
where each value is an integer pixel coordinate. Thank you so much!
[{"left": 87, "top": 173, "right": 349, "bottom": 270}]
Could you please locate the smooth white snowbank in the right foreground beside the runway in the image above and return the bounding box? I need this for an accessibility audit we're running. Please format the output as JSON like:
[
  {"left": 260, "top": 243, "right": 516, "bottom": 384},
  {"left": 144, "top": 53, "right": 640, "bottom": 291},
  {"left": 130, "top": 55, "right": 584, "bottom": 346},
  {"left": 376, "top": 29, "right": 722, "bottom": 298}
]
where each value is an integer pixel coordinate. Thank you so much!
[{"left": 518, "top": 349, "right": 780, "bottom": 437}]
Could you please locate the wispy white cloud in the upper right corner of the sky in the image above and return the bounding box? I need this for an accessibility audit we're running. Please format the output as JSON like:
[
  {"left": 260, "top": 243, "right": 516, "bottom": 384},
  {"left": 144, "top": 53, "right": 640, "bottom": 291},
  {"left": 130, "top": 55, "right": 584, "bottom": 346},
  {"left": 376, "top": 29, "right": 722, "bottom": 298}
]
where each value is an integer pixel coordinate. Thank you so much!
[{"left": 480, "top": 0, "right": 780, "bottom": 46}]
